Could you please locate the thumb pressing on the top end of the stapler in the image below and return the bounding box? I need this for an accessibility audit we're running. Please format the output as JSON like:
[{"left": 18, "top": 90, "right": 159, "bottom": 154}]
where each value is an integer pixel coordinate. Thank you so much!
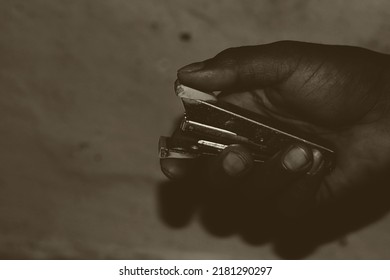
[{"left": 177, "top": 41, "right": 300, "bottom": 91}]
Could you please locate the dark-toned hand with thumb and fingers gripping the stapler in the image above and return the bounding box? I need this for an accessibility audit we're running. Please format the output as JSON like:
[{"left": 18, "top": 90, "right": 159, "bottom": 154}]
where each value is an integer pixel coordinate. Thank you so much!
[{"left": 161, "top": 41, "right": 390, "bottom": 216}]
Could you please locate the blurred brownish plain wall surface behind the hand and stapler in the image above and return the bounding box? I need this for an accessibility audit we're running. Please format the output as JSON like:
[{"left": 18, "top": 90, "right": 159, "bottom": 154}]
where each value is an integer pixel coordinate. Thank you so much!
[{"left": 0, "top": 0, "right": 390, "bottom": 259}]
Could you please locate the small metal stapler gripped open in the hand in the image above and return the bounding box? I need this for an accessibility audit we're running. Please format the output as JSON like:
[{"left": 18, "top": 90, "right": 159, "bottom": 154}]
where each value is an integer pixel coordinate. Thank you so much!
[{"left": 159, "top": 82, "right": 335, "bottom": 169}]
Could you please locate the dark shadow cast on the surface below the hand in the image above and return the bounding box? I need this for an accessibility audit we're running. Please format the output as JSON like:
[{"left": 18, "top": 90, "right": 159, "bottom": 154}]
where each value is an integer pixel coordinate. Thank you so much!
[{"left": 157, "top": 175, "right": 390, "bottom": 259}]
